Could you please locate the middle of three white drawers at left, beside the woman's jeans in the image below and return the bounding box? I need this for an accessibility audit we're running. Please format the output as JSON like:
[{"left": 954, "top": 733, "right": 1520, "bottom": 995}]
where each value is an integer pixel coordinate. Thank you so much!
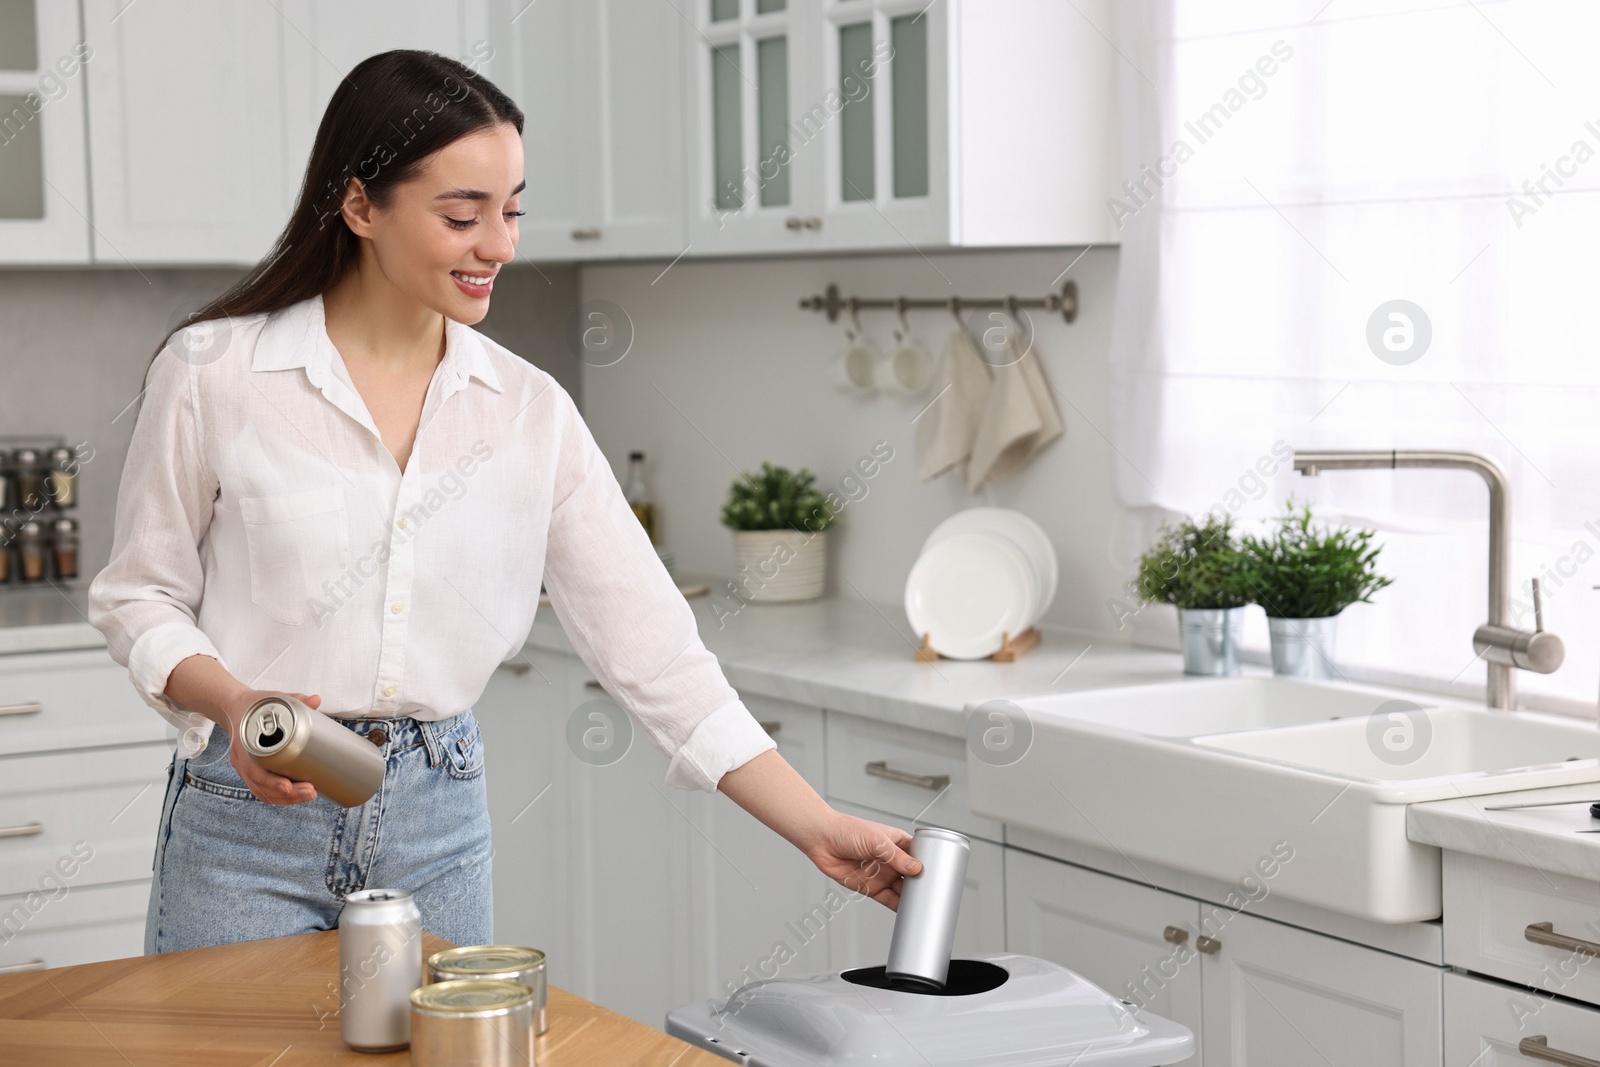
[{"left": 0, "top": 744, "right": 171, "bottom": 896}]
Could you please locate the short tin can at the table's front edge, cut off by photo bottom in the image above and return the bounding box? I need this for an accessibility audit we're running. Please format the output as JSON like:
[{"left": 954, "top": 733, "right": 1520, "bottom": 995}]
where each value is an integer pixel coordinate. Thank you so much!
[{"left": 411, "top": 979, "right": 533, "bottom": 1067}]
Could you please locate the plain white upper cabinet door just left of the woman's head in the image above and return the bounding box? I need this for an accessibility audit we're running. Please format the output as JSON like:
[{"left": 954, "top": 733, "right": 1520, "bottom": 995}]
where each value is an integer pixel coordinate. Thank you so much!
[{"left": 82, "top": 0, "right": 306, "bottom": 264}]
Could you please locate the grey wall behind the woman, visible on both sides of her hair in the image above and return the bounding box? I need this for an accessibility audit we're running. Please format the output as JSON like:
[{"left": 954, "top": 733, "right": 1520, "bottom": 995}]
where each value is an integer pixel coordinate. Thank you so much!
[{"left": 0, "top": 264, "right": 581, "bottom": 595}]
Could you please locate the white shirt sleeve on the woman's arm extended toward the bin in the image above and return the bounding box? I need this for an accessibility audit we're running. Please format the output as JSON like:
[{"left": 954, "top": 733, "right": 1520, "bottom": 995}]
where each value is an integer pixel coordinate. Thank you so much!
[{"left": 544, "top": 386, "right": 776, "bottom": 792}]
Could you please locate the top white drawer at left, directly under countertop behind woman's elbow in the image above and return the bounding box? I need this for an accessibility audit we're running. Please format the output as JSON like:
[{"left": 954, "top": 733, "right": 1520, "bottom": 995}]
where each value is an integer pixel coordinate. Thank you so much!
[{"left": 0, "top": 649, "right": 170, "bottom": 755}]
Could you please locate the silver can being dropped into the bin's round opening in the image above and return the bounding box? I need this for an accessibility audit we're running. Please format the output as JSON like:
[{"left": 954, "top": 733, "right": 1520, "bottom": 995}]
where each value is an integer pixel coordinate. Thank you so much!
[{"left": 883, "top": 827, "right": 971, "bottom": 990}]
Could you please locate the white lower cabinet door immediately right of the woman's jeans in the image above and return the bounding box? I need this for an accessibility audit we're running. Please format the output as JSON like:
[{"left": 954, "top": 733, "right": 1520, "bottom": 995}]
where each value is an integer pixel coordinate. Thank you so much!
[{"left": 474, "top": 649, "right": 573, "bottom": 989}]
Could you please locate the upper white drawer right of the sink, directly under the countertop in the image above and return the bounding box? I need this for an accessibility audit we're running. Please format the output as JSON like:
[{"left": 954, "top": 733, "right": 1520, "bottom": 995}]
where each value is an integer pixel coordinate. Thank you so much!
[{"left": 1445, "top": 851, "right": 1600, "bottom": 1005}]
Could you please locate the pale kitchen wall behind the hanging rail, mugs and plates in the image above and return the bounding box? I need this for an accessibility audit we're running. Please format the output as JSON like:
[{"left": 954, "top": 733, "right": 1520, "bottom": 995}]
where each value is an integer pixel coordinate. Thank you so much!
[{"left": 581, "top": 248, "right": 1139, "bottom": 630}]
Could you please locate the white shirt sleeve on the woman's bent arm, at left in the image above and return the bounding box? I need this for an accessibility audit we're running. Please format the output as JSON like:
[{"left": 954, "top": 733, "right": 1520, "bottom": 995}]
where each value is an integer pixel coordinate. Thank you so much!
[{"left": 88, "top": 347, "right": 222, "bottom": 757}]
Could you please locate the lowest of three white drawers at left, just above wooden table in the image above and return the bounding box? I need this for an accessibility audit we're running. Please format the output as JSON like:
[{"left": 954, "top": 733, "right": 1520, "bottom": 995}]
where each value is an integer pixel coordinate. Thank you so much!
[{"left": 0, "top": 878, "right": 150, "bottom": 974}]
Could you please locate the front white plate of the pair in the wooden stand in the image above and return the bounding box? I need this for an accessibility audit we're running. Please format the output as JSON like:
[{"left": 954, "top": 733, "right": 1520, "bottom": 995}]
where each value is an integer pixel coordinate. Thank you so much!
[{"left": 906, "top": 530, "right": 1038, "bottom": 659}]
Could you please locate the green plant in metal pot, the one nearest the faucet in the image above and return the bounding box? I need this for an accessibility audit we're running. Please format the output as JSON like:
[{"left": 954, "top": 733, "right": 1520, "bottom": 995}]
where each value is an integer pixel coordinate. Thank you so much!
[{"left": 1243, "top": 501, "right": 1394, "bottom": 678}]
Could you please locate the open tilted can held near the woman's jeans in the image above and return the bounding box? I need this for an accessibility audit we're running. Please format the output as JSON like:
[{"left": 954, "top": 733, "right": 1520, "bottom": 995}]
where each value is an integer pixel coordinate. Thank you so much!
[{"left": 238, "top": 696, "right": 384, "bottom": 808}]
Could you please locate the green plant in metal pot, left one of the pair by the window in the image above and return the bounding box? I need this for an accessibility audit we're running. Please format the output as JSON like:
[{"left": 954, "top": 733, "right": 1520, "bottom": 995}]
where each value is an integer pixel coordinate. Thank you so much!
[{"left": 1136, "top": 514, "right": 1250, "bottom": 675}]
